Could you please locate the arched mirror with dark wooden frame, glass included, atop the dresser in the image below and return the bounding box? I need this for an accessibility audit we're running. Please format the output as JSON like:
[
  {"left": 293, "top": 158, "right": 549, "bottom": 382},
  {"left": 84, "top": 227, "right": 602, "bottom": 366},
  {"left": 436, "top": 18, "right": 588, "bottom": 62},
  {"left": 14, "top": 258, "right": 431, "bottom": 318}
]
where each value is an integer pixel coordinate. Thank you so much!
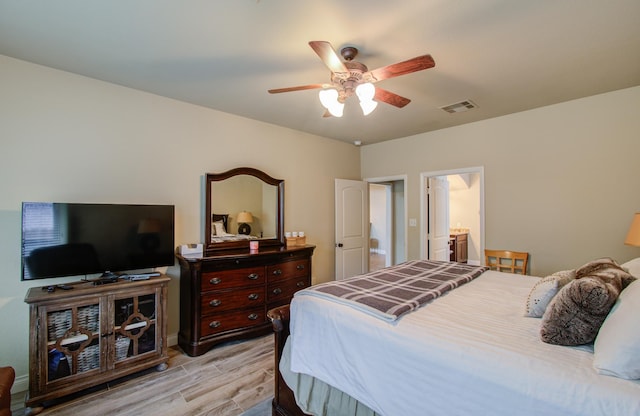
[{"left": 204, "top": 168, "right": 284, "bottom": 255}]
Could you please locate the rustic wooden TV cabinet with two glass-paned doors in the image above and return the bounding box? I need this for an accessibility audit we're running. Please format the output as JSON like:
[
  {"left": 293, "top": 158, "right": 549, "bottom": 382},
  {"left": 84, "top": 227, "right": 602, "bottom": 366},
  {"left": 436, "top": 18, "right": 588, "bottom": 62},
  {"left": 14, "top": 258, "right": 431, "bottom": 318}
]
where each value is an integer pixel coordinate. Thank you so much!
[{"left": 25, "top": 275, "right": 169, "bottom": 414}]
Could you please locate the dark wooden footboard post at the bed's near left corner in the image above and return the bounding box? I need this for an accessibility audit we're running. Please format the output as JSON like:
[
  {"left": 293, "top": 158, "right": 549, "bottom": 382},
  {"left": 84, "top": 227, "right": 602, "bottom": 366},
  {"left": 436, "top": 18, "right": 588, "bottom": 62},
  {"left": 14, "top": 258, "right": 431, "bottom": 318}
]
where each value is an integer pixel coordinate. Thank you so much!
[{"left": 267, "top": 305, "right": 305, "bottom": 416}]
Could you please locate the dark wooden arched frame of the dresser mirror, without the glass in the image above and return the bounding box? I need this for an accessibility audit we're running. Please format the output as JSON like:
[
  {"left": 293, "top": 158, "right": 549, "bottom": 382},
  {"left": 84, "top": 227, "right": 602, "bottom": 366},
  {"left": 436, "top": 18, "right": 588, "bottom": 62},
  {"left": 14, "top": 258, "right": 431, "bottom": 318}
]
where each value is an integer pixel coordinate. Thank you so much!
[{"left": 204, "top": 167, "right": 284, "bottom": 256}]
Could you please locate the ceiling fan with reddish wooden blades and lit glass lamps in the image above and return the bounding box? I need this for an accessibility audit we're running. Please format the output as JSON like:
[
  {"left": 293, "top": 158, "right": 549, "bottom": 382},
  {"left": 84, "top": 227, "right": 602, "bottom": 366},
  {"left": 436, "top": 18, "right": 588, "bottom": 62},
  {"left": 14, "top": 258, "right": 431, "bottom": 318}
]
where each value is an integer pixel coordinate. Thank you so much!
[{"left": 269, "top": 41, "right": 436, "bottom": 117}]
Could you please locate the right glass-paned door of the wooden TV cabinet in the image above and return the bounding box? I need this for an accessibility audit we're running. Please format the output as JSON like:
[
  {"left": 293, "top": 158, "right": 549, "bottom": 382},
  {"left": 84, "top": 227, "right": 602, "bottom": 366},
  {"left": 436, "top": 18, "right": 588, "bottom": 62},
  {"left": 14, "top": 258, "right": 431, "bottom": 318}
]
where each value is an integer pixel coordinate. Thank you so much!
[{"left": 114, "top": 292, "right": 158, "bottom": 363}]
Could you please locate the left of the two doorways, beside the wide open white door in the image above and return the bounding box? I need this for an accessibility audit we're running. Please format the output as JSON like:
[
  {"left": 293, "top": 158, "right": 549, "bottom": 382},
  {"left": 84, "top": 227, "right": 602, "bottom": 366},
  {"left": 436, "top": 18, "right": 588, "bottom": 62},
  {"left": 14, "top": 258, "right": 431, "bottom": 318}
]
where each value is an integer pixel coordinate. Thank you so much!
[{"left": 366, "top": 176, "right": 407, "bottom": 271}]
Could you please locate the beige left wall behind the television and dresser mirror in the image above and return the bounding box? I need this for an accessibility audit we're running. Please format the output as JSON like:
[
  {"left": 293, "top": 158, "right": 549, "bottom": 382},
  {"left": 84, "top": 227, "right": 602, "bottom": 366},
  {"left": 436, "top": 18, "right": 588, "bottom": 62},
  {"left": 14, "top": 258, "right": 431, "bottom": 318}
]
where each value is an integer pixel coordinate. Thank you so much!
[{"left": 0, "top": 56, "right": 360, "bottom": 388}]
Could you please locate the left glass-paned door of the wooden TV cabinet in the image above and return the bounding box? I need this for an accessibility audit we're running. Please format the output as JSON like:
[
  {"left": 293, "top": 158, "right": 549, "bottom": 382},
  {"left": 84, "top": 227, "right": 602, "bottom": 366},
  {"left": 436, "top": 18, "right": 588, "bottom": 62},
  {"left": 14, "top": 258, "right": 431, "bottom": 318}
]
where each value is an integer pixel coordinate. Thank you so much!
[{"left": 41, "top": 300, "right": 102, "bottom": 382}]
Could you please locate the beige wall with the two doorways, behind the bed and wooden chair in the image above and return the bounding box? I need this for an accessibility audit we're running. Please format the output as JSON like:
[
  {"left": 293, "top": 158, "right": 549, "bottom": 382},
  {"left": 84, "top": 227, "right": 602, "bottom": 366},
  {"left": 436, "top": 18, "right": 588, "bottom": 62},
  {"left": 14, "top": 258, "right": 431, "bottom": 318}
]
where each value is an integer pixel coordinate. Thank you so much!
[{"left": 361, "top": 87, "right": 640, "bottom": 275}]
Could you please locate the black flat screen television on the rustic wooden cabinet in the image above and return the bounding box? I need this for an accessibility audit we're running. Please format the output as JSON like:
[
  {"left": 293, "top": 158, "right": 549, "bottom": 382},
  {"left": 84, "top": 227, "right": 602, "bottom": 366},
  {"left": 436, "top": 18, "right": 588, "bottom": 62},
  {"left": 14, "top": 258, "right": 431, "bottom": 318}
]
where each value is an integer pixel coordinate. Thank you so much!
[{"left": 21, "top": 202, "right": 175, "bottom": 280}]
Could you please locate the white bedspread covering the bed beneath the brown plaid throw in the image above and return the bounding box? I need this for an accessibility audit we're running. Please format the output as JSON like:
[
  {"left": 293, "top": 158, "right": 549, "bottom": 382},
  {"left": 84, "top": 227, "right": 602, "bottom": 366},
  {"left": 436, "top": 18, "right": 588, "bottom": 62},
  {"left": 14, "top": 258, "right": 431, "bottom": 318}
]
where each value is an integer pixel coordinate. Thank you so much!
[{"left": 291, "top": 271, "right": 640, "bottom": 416}]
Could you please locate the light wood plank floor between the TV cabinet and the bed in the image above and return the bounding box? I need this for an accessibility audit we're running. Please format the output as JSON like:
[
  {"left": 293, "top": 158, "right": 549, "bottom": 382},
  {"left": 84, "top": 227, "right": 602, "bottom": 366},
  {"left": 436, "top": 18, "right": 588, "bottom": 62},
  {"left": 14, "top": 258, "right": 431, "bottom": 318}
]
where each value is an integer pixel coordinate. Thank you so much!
[{"left": 12, "top": 335, "right": 274, "bottom": 416}]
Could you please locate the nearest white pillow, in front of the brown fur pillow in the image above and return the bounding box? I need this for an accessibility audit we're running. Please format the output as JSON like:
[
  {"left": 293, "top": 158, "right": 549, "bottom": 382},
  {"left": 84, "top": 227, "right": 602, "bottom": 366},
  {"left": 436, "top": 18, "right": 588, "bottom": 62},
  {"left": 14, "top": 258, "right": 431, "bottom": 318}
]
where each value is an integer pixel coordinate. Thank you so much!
[{"left": 593, "top": 282, "right": 640, "bottom": 380}]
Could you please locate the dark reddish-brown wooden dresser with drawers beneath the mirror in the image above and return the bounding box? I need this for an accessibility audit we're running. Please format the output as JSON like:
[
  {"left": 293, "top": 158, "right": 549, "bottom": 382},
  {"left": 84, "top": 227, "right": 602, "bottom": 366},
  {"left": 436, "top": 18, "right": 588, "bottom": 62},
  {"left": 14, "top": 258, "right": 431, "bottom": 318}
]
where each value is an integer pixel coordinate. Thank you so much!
[{"left": 177, "top": 245, "right": 315, "bottom": 356}]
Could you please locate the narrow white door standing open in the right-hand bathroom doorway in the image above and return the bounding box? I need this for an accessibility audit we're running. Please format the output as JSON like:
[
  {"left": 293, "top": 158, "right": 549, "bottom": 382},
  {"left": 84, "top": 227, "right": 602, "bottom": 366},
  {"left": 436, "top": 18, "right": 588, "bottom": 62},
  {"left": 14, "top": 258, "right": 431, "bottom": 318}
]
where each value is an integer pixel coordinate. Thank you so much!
[{"left": 427, "top": 176, "right": 450, "bottom": 261}]
